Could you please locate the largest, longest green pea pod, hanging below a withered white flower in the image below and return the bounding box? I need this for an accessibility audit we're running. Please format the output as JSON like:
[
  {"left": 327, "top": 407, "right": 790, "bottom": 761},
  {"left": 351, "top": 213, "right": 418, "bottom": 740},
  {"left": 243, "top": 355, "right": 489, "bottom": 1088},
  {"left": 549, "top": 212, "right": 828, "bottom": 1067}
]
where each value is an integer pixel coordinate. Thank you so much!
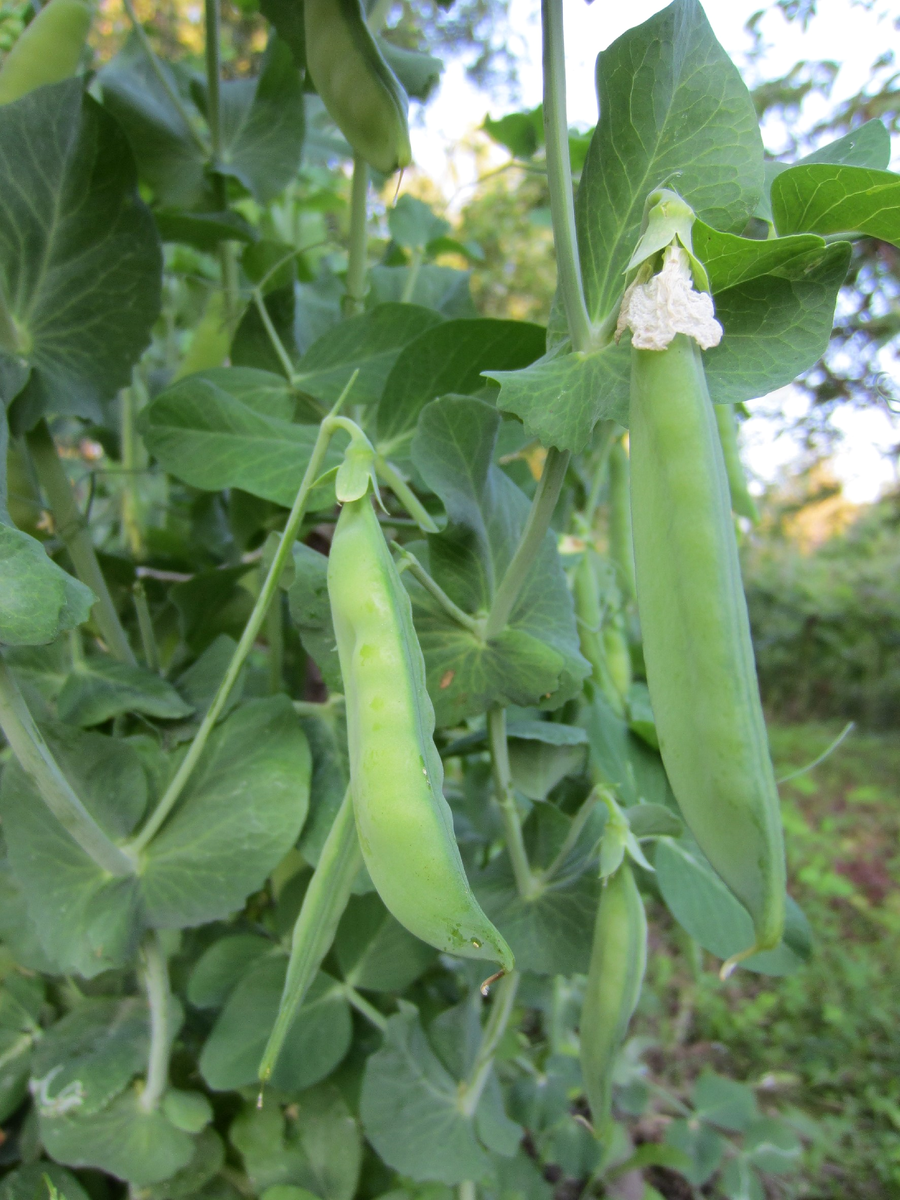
[{"left": 630, "top": 334, "right": 785, "bottom": 961}]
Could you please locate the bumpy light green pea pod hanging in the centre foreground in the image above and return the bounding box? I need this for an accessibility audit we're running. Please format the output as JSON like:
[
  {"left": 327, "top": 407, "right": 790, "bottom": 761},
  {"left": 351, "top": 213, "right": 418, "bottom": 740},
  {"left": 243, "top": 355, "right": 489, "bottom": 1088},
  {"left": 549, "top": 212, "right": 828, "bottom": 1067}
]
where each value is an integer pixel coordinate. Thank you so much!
[{"left": 328, "top": 496, "right": 514, "bottom": 971}]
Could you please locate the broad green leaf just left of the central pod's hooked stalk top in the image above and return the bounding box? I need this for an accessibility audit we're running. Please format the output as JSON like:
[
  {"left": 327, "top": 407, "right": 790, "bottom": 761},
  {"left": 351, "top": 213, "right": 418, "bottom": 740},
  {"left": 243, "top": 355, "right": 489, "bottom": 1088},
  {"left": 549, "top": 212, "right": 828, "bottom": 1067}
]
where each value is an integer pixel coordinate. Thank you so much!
[{"left": 140, "top": 367, "right": 341, "bottom": 508}]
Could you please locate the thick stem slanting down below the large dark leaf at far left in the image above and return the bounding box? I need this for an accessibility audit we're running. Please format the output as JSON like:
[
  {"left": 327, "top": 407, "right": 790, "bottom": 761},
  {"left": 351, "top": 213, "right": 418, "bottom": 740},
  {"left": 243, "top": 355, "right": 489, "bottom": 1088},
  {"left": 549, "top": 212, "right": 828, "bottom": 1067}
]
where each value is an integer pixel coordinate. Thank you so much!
[{"left": 25, "top": 420, "right": 136, "bottom": 664}]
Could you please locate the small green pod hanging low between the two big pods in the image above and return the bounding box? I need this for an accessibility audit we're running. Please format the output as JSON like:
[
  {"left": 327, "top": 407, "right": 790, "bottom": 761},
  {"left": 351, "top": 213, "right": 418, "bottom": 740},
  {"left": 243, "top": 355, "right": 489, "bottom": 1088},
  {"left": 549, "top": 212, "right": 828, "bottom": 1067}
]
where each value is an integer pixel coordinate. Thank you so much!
[{"left": 580, "top": 860, "right": 647, "bottom": 1135}]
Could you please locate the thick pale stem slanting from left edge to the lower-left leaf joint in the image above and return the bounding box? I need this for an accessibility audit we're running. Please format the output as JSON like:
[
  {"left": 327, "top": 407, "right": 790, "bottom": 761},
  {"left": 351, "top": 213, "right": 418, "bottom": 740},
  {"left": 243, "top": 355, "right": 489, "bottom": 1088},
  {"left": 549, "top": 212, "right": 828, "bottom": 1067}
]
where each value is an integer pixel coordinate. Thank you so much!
[{"left": 0, "top": 656, "right": 134, "bottom": 876}]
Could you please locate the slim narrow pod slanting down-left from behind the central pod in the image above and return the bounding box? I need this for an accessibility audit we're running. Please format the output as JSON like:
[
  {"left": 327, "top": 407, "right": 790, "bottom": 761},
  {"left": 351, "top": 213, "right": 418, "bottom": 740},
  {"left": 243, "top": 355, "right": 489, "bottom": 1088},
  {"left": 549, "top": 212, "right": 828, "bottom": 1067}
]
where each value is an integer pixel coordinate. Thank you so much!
[{"left": 259, "top": 787, "right": 362, "bottom": 1082}]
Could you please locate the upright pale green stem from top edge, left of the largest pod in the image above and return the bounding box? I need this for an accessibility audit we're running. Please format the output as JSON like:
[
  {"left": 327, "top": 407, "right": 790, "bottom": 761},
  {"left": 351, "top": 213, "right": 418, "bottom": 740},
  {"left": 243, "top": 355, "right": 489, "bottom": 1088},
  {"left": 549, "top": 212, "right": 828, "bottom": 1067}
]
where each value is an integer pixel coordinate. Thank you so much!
[{"left": 541, "top": 0, "right": 592, "bottom": 352}]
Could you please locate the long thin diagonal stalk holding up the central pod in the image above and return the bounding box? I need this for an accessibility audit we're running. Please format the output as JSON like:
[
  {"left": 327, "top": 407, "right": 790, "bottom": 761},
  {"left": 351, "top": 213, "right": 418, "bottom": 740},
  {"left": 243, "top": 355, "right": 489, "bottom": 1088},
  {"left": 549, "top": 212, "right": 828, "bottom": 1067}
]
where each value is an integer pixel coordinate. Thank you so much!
[{"left": 132, "top": 389, "right": 348, "bottom": 851}]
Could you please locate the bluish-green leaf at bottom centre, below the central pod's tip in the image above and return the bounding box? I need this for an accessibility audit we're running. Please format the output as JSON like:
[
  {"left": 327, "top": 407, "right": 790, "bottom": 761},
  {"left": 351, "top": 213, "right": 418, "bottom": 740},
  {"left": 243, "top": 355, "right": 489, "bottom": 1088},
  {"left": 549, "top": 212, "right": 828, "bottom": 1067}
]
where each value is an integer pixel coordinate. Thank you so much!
[{"left": 360, "top": 1002, "right": 491, "bottom": 1184}]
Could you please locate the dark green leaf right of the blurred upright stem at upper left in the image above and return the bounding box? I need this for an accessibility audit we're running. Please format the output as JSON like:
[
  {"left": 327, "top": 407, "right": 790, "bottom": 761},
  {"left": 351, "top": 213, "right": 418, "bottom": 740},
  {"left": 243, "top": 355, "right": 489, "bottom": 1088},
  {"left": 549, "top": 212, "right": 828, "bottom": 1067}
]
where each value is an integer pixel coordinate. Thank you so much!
[{"left": 215, "top": 38, "right": 305, "bottom": 204}]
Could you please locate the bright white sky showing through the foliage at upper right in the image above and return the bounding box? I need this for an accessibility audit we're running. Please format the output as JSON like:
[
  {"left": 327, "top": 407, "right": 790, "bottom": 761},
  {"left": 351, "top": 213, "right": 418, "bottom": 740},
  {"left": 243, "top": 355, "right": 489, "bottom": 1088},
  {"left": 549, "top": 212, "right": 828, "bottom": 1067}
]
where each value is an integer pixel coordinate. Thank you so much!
[{"left": 410, "top": 0, "right": 900, "bottom": 504}]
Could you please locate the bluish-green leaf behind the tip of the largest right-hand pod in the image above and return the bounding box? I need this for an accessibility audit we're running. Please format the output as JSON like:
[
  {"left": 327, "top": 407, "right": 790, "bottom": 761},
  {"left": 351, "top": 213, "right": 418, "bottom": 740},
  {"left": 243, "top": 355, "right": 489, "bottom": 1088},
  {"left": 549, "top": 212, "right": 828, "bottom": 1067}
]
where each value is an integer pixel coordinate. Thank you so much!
[{"left": 654, "top": 839, "right": 810, "bottom": 976}]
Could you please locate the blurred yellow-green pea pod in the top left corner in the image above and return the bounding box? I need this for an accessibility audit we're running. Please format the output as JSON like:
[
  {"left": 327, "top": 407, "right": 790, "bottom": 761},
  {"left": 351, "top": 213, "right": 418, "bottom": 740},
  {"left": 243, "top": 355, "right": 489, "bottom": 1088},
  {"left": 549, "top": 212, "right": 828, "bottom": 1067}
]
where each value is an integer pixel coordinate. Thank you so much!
[{"left": 0, "top": 0, "right": 91, "bottom": 104}]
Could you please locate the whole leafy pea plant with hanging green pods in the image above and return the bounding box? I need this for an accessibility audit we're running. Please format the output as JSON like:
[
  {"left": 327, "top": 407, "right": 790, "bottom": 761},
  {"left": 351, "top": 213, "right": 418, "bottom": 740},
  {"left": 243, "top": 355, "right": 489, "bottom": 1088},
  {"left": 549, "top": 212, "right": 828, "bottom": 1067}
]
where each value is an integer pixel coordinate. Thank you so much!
[{"left": 0, "top": 0, "right": 900, "bottom": 1200}]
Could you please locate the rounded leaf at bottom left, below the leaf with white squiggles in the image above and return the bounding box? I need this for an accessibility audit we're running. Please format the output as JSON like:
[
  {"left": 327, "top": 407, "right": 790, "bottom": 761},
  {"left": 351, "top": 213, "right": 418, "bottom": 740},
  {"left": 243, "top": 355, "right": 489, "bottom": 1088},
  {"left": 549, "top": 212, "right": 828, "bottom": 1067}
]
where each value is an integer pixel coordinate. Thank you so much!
[{"left": 40, "top": 1088, "right": 194, "bottom": 1187}]
